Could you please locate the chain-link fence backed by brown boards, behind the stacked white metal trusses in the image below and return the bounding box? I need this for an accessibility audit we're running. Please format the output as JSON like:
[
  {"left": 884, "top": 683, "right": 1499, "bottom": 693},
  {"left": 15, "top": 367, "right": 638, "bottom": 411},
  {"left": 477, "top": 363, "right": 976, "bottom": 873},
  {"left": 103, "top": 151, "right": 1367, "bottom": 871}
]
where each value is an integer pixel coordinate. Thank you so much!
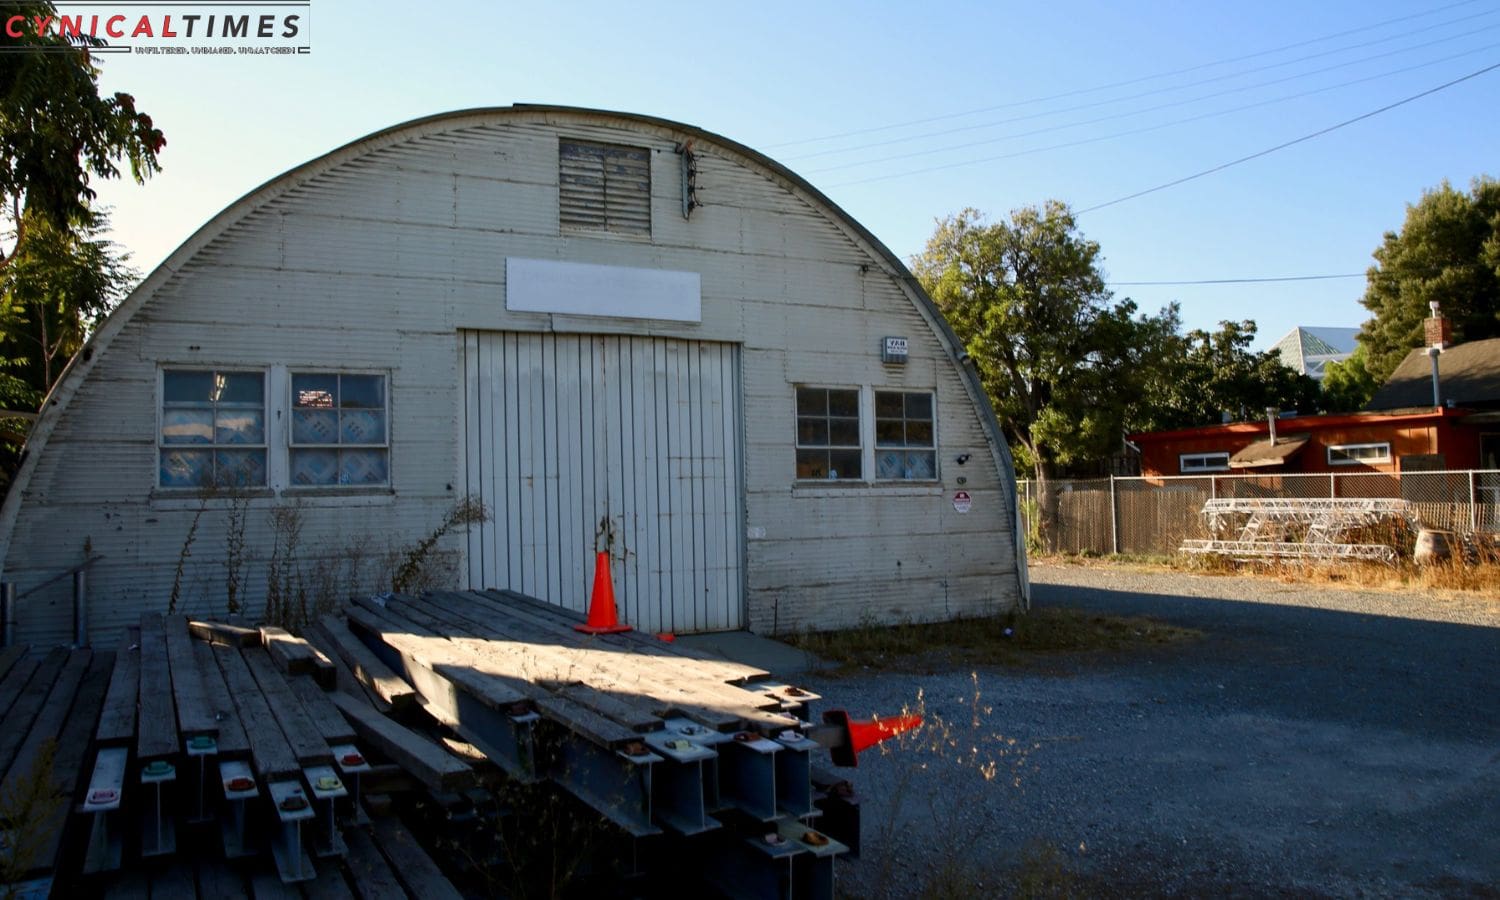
[{"left": 1017, "top": 470, "right": 1500, "bottom": 557}]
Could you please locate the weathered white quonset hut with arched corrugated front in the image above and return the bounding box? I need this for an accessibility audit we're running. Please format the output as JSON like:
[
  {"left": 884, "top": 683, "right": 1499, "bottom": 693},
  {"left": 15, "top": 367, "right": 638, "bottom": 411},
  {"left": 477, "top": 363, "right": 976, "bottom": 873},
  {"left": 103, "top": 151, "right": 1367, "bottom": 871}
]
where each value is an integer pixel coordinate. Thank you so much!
[{"left": 0, "top": 107, "right": 1028, "bottom": 644}]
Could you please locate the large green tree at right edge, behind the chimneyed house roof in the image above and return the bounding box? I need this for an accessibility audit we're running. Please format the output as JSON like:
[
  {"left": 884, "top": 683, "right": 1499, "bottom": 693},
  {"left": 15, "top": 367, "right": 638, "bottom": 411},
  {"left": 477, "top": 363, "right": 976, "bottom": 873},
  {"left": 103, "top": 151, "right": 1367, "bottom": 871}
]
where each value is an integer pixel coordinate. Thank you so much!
[{"left": 1359, "top": 176, "right": 1500, "bottom": 384}]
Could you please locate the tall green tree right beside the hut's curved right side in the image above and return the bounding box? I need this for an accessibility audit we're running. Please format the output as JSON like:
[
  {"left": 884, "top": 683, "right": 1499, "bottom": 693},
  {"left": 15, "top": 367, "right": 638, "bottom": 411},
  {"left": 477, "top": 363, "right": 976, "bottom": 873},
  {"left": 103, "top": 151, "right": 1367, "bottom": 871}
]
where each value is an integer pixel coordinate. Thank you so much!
[{"left": 912, "top": 201, "right": 1178, "bottom": 540}]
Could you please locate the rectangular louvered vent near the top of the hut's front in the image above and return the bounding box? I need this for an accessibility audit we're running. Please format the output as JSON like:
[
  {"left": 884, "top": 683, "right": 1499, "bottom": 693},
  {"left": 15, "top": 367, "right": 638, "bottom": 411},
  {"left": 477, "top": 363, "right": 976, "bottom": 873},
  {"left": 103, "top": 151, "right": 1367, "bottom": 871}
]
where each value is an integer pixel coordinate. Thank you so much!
[{"left": 558, "top": 141, "right": 651, "bottom": 236}]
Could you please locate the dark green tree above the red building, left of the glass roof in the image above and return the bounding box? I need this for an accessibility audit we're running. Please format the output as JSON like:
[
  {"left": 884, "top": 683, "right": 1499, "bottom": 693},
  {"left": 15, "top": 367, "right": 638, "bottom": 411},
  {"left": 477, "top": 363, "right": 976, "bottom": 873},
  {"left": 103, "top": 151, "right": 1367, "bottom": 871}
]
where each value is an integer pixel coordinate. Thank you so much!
[{"left": 1130, "top": 320, "right": 1322, "bottom": 431}]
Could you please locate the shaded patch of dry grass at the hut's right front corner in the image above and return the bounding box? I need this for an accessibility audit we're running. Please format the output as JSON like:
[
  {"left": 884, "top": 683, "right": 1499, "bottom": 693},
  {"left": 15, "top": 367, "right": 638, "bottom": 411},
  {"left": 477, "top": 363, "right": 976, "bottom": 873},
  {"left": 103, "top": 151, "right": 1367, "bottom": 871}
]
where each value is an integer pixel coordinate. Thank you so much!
[{"left": 788, "top": 608, "right": 1202, "bottom": 671}]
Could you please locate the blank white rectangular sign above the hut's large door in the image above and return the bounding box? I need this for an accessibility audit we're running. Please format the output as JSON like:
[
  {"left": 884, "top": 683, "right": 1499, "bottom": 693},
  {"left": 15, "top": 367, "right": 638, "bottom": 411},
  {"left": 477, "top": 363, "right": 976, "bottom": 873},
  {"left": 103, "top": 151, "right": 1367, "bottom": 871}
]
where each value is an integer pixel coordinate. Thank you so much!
[{"left": 506, "top": 257, "right": 704, "bottom": 323}]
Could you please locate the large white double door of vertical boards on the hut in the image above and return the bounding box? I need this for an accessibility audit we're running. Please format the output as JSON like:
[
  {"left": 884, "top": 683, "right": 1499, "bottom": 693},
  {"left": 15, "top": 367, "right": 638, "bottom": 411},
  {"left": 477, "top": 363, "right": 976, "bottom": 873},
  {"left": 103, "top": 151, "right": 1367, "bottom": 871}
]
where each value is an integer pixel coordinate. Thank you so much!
[{"left": 462, "top": 332, "right": 744, "bottom": 633}]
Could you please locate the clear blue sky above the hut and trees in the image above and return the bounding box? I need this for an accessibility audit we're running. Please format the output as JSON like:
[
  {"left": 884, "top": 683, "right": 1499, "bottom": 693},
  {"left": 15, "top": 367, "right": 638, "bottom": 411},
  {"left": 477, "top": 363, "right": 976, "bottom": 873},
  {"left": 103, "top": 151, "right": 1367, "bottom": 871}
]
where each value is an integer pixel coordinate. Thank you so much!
[{"left": 85, "top": 0, "right": 1500, "bottom": 347}]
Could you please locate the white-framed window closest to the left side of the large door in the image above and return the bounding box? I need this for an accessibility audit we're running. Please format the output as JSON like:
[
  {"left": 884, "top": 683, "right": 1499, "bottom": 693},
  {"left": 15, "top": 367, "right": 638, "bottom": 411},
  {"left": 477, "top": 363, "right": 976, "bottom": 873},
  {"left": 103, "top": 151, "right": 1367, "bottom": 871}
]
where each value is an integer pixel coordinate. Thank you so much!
[{"left": 290, "top": 372, "right": 390, "bottom": 488}]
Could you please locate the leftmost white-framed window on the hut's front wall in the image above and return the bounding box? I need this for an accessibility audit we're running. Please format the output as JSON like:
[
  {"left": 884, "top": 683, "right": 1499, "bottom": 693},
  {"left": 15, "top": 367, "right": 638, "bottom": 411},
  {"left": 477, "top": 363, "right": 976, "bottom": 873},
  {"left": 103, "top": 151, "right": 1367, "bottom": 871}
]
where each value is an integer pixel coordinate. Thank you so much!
[{"left": 156, "top": 369, "right": 267, "bottom": 489}]
